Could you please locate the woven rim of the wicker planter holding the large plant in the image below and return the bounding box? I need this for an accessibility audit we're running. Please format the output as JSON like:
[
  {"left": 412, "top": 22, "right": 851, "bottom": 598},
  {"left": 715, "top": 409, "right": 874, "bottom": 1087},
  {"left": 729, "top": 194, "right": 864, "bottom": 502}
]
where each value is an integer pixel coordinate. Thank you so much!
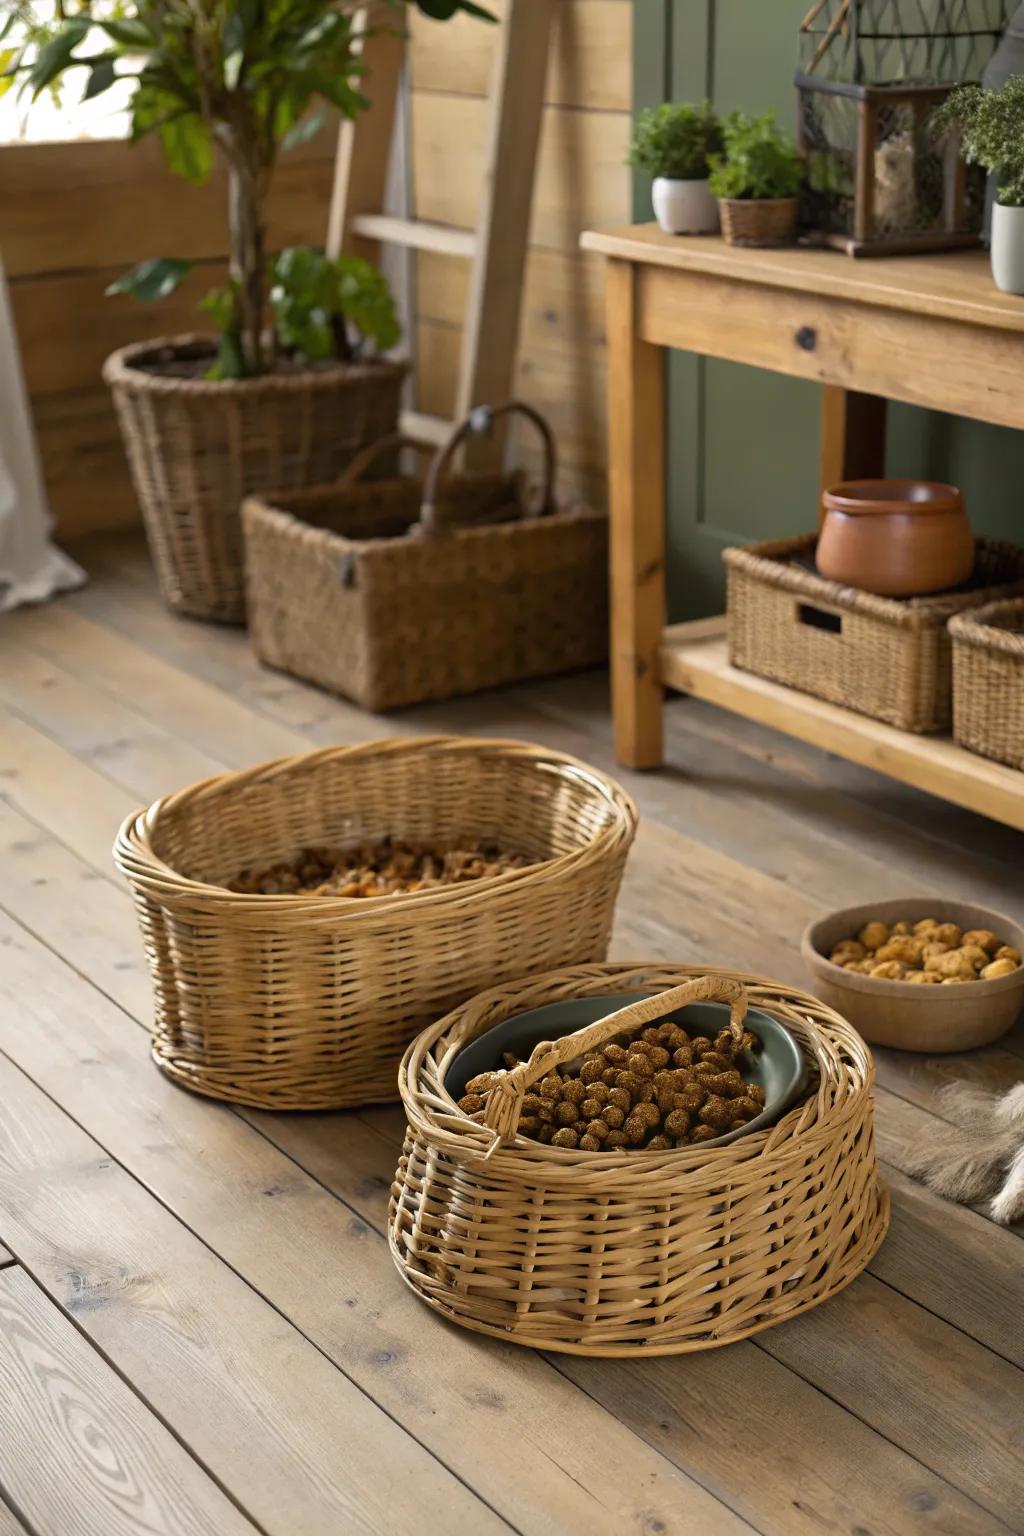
[{"left": 103, "top": 332, "right": 408, "bottom": 399}]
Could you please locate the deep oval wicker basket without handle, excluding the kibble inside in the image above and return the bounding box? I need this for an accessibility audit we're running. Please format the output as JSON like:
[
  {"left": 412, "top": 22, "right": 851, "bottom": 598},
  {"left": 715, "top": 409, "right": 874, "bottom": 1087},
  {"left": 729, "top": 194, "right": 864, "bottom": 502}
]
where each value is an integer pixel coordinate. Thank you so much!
[{"left": 114, "top": 737, "right": 636, "bottom": 1109}]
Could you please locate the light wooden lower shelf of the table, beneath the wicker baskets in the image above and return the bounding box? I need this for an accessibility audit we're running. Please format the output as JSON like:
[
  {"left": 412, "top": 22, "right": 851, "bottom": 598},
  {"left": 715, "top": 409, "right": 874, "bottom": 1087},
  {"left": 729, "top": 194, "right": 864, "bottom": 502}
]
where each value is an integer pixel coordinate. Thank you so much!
[{"left": 660, "top": 617, "right": 1024, "bottom": 829}]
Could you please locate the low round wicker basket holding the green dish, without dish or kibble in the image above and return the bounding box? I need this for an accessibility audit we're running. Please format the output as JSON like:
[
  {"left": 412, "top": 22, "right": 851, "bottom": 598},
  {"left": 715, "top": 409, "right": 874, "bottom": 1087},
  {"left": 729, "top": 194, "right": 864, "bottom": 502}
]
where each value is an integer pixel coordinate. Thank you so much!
[{"left": 390, "top": 965, "right": 889, "bottom": 1355}]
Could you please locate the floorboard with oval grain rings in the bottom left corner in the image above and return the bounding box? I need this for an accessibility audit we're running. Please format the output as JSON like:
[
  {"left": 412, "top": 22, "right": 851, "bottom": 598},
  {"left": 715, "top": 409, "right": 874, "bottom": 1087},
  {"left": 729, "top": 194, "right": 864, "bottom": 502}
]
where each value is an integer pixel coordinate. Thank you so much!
[{"left": 0, "top": 1270, "right": 255, "bottom": 1536}]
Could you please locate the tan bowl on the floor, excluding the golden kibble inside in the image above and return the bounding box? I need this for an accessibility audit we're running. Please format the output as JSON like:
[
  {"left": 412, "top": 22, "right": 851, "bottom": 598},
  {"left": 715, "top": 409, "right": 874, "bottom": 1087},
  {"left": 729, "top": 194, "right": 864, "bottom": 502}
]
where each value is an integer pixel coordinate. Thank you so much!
[{"left": 800, "top": 895, "right": 1024, "bottom": 1052}]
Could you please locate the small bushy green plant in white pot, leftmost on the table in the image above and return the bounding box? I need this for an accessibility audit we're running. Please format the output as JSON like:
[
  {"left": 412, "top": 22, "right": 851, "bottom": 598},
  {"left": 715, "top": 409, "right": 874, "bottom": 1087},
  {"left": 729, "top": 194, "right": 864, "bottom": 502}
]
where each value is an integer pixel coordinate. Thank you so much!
[{"left": 629, "top": 101, "right": 723, "bottom": 235}]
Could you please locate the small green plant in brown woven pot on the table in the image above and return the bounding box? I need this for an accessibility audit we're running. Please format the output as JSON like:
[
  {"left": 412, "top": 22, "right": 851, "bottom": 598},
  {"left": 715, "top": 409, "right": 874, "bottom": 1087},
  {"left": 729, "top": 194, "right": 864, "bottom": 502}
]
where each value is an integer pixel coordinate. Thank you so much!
[{"left": 711, "top": 112, "right": 803, "bottom": 246}]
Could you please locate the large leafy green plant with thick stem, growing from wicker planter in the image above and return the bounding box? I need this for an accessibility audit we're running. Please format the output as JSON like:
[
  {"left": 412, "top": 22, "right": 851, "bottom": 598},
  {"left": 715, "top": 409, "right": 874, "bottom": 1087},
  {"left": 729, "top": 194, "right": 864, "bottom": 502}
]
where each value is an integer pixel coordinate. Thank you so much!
[{"left": 0, "top": 0, "right": 488, "bottom": 378}]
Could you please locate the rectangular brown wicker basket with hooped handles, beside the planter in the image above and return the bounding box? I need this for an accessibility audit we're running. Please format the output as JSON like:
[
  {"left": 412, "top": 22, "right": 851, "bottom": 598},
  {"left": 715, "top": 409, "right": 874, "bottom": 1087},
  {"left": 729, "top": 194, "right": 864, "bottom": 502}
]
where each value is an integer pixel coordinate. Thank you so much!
[{"left": 243, "top": 404, "right": 608, "bottom": 710}]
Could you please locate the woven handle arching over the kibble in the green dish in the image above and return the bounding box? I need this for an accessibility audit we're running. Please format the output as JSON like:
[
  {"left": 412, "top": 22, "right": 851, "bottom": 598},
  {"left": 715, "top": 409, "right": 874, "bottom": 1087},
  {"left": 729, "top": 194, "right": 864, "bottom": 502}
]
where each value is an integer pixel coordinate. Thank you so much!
[{"left": 484, "top": 975, "right": 748, "bottom": 1150}]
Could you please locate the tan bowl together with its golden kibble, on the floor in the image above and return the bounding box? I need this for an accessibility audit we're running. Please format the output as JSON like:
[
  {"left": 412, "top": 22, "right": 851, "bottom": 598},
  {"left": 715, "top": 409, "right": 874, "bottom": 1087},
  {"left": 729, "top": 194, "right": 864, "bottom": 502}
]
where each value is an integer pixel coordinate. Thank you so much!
[{"left": 801, "top": 897, "right": 1024, "bottom": 1052}]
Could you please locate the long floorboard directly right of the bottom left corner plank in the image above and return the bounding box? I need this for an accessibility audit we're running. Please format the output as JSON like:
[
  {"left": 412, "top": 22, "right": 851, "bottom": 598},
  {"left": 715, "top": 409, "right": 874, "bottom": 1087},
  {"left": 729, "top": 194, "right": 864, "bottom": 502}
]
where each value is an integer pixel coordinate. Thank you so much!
[{"left": 0, "top": 1050, "right": 507, "bottom": 1536}]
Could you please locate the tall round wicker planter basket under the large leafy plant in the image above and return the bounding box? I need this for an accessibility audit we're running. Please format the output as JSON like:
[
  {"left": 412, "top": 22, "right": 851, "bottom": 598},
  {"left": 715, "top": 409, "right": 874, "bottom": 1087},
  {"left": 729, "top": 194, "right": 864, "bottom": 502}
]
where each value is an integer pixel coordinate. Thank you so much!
[{"left": 103, "top": 336, "right": 405, "bottom": 624}]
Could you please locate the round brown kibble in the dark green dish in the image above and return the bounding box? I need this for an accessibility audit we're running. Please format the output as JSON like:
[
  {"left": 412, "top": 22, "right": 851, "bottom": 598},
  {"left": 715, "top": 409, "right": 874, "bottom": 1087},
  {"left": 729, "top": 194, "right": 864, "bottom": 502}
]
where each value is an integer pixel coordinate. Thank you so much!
[{"left": 459, "top": 1025, "right": 765, "bottom": 1152}]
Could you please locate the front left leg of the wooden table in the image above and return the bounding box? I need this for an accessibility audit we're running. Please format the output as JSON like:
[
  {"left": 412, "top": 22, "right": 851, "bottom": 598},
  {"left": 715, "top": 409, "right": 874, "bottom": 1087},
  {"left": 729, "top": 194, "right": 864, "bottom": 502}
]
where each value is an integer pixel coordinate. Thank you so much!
[{"left": 605, "top": 260, "right": 665, "bottom": 780}]
